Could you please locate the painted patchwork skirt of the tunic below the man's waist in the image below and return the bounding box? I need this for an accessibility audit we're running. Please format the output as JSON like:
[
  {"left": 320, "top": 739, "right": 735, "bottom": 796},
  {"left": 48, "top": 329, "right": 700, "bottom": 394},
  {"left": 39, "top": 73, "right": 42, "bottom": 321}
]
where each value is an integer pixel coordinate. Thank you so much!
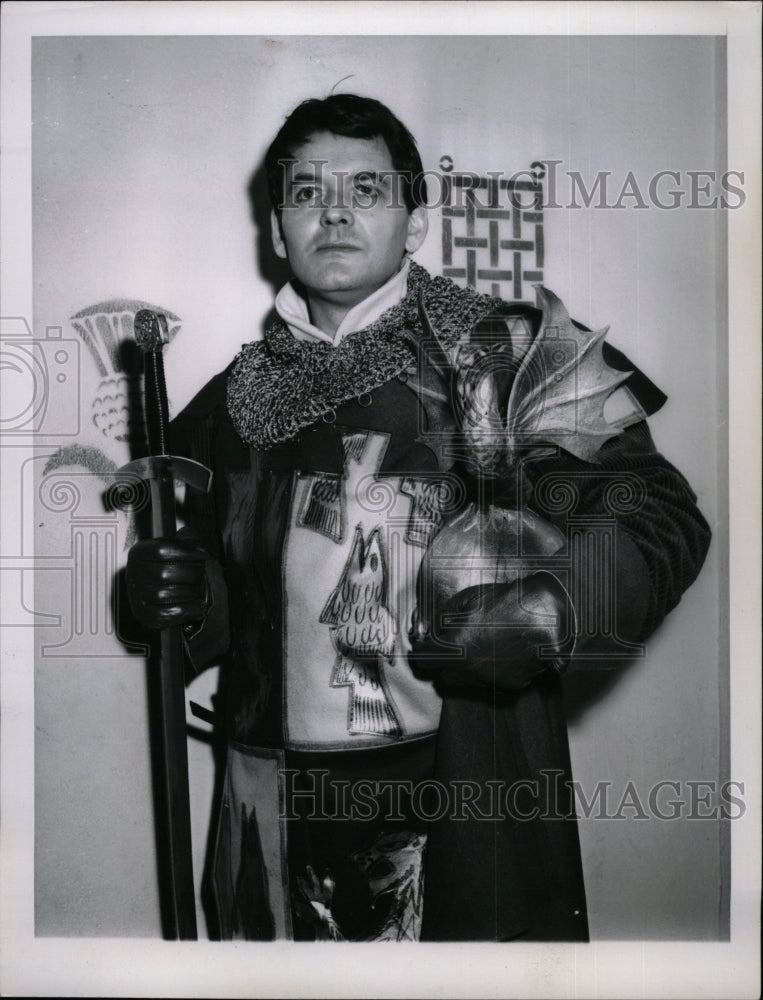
[{"left": 212, "top": 736, "right": 435, "bottom": 941}]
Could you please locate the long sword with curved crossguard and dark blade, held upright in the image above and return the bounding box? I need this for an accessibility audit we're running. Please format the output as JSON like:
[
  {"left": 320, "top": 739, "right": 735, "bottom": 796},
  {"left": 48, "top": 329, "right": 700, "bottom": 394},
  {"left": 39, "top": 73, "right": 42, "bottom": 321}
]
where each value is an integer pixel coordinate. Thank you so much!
[{"left": 119, "top": 309, "right": 212, "bottom": 940}]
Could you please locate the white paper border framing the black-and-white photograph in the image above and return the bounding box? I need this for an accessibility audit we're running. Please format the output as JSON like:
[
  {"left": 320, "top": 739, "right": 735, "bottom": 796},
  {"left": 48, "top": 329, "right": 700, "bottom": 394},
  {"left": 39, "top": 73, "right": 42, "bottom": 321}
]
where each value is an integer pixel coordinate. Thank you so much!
[{"left": 0, "top": 0, "right": 761, "bottom": 998}]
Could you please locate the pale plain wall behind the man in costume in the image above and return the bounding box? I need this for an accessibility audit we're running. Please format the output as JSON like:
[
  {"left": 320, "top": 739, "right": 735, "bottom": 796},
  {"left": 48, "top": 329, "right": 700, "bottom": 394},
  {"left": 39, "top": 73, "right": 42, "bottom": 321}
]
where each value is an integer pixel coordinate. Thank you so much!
[{"left": 33, "top": 33, "right": 727, "bottom": 939}]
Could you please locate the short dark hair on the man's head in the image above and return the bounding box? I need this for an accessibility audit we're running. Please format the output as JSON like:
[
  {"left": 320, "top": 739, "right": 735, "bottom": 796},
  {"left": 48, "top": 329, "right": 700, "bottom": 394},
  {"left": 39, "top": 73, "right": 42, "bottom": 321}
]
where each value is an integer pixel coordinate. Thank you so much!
[{"left": 265, "top": 94, "right": 426, "bottom": 215}]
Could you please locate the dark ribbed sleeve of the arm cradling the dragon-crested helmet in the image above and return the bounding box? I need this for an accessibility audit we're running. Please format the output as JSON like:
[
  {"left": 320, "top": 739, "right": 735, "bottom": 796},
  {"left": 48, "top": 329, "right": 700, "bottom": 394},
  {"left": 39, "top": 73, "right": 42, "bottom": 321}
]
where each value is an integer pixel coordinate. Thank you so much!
[{"left": 528, "top": 421, "right": 710, "bottom": 656}]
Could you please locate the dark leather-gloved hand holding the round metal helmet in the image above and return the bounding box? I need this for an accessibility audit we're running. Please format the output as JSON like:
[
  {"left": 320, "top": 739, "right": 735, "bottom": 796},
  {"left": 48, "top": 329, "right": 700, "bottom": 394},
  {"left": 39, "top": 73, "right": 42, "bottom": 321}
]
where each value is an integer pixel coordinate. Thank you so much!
[{"left": 408, "top": 573, "right": 573, "bottom": 691}]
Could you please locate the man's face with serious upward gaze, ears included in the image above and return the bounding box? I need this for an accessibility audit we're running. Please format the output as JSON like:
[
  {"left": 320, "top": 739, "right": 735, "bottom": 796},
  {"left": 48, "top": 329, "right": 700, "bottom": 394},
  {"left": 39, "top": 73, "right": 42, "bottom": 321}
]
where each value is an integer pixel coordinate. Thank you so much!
[{"left": 272, "top": 132, "right": 427, "bottom": 310}]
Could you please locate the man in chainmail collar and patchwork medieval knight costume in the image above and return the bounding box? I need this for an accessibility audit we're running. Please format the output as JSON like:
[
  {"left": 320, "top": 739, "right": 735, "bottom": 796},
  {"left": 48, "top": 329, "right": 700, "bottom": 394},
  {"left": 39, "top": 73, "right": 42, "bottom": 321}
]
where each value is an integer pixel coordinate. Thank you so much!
[{"left": 128, "top": 94, "right": 709, "bottom": 941}]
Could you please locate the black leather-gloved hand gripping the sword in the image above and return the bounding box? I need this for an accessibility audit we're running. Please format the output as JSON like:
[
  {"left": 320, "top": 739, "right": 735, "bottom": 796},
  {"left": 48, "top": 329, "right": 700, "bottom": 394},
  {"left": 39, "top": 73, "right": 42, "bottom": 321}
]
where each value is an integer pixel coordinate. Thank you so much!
[{"left": 125, "top": 534, "right": 211, "bottom": 629}]
